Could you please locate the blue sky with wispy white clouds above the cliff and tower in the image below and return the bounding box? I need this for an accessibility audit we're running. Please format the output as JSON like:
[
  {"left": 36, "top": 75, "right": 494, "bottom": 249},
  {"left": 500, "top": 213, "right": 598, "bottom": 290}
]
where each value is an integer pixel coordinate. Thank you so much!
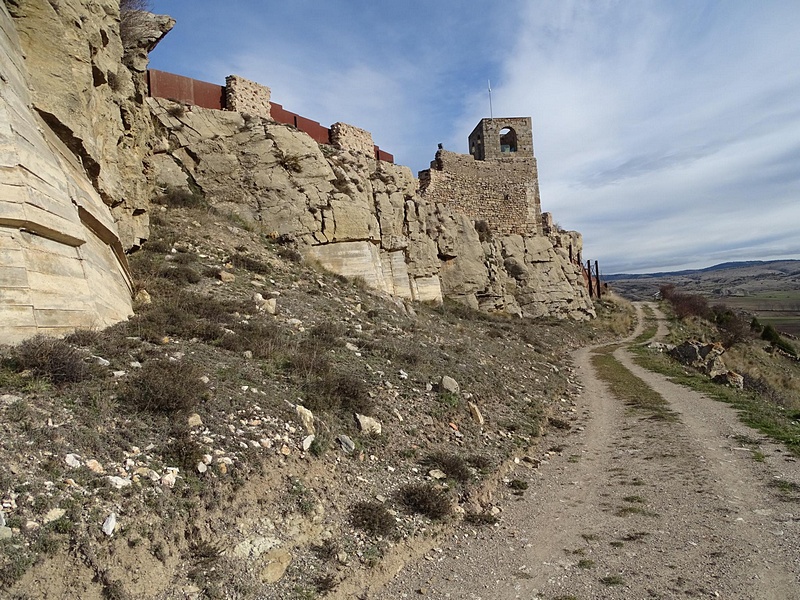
[{"left": 151, "top": 0, "right": 800, "bottom": 273}]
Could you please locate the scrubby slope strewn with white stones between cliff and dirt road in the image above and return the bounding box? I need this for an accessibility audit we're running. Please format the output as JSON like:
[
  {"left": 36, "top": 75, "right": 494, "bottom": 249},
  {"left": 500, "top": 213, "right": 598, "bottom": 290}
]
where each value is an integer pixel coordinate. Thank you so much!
[{"left": 0, "top": 206, "right": 625, "bottom": 599}]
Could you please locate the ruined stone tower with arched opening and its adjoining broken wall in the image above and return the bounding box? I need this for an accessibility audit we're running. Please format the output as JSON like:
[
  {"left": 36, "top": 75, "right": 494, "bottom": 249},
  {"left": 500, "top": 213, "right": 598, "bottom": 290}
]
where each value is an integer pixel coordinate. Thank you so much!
[{"left": 419, "top": 117, "right": 542, "bottom": 235}]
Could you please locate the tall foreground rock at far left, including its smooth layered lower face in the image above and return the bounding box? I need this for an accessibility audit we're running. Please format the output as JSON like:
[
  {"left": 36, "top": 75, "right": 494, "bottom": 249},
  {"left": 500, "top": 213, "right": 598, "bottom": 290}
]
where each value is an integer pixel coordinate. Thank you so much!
[{"left": 0, "top": 0, "right": 170, "bottom": 343}]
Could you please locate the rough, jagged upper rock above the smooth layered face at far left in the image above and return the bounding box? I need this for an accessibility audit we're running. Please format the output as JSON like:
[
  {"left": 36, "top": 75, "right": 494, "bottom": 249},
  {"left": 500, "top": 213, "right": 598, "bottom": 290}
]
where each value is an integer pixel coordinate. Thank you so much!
[{"left": 7, "top": 0, "right": 175, "bottom": 250}]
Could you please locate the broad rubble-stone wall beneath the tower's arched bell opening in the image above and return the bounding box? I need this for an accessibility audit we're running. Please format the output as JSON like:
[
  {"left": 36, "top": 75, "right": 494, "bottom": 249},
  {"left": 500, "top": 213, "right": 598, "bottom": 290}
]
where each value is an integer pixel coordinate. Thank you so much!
[{"left": 419, "top": 150, "right": 542, "bottom": 235}]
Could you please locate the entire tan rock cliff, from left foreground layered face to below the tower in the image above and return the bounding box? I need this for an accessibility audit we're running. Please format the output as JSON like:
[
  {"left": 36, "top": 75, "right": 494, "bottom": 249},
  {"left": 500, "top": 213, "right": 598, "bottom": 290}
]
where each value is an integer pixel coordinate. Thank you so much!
[{"left": 0, "top": 0, "right": 594, "bottom": 342}]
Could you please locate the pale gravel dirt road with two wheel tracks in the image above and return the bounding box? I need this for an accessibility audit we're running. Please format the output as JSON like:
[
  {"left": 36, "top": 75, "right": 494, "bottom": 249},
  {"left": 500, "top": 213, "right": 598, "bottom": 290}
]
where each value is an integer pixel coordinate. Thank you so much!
[{"left": 370, "top": 307, "right": 800, "bottom": 600}]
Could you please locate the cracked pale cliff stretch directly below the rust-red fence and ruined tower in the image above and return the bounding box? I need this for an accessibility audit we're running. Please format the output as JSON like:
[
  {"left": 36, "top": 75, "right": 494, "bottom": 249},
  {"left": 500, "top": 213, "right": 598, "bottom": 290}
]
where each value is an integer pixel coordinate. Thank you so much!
[{"left": 148, "top": 99, "right": 594, "bottom": 319}]
